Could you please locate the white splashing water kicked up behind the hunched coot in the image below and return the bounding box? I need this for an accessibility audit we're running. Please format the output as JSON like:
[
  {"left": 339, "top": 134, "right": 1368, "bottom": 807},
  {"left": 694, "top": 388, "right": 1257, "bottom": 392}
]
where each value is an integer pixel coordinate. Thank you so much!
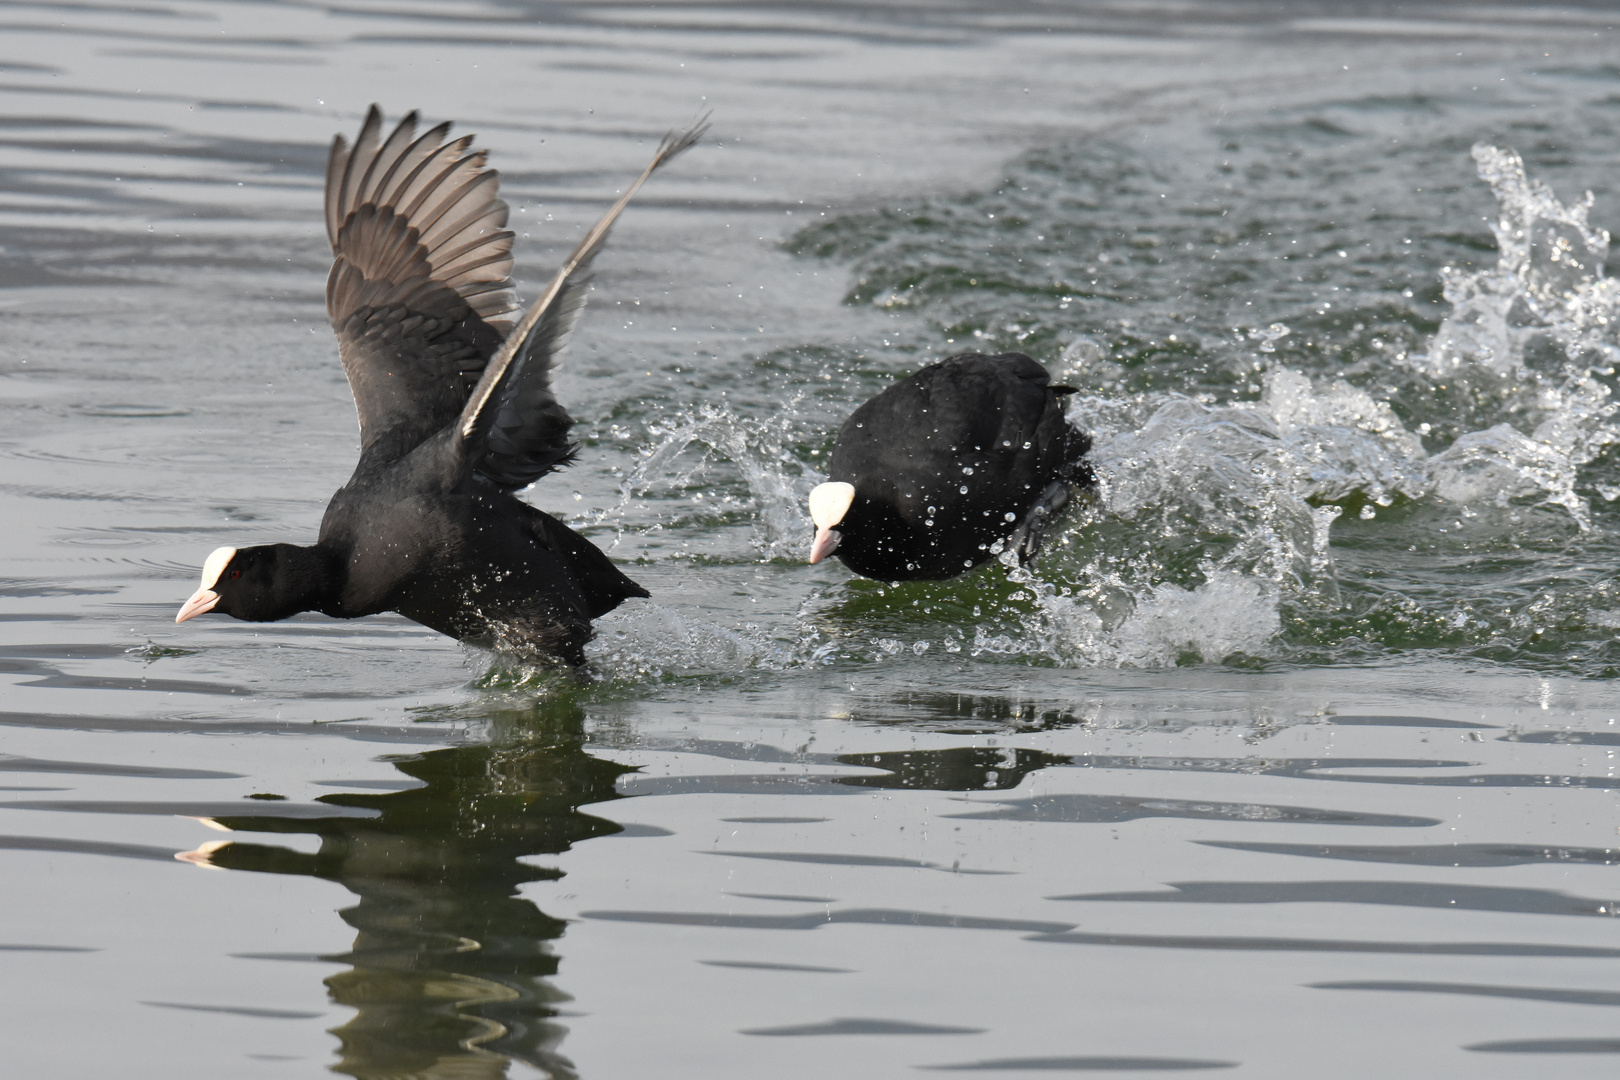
[{"left": 926, "top": 146, "right": 1620, "bottom": 667}]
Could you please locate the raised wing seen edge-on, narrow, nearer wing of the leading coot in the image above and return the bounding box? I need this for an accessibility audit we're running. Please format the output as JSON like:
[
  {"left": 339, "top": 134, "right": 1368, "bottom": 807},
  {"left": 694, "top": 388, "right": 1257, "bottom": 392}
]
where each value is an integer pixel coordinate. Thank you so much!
[{"left": 458, "top": 115, "right": 708, "bottom": 489}]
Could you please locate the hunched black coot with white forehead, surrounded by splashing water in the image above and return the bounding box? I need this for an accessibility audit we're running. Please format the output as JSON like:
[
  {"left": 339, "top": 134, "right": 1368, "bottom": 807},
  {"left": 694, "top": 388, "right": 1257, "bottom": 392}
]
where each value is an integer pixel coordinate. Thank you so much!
[{"left": 810, "top": 353, "right": 1095, "bottom": 581}]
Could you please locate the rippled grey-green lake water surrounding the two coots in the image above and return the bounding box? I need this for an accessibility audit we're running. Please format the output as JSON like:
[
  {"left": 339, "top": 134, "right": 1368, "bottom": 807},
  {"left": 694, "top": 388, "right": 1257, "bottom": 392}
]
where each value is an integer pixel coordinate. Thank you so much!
[{"left": 0, "top": 0, "right": 1620, "bottom": 1080}]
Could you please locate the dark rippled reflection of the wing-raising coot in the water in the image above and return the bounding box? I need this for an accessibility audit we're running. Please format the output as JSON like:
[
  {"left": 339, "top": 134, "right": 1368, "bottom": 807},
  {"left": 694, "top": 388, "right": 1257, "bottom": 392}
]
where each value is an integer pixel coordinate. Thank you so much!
[{"left": 181, "top": 703, "right": 632, "bottom": 1080}]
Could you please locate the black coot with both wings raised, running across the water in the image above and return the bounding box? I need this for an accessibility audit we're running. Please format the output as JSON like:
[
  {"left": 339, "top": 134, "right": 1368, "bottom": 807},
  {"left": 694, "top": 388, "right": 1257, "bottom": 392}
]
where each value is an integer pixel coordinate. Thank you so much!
[{"left": 175, "top": 105, "right": 706, "bottom": 667}]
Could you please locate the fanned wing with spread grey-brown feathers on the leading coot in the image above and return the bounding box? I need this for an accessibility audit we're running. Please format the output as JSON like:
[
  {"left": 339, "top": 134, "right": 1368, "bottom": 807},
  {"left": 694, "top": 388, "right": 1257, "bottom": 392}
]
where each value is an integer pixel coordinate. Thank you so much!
[{"left": 326, "top": 105, "right": 515, "bottom": 457}]
